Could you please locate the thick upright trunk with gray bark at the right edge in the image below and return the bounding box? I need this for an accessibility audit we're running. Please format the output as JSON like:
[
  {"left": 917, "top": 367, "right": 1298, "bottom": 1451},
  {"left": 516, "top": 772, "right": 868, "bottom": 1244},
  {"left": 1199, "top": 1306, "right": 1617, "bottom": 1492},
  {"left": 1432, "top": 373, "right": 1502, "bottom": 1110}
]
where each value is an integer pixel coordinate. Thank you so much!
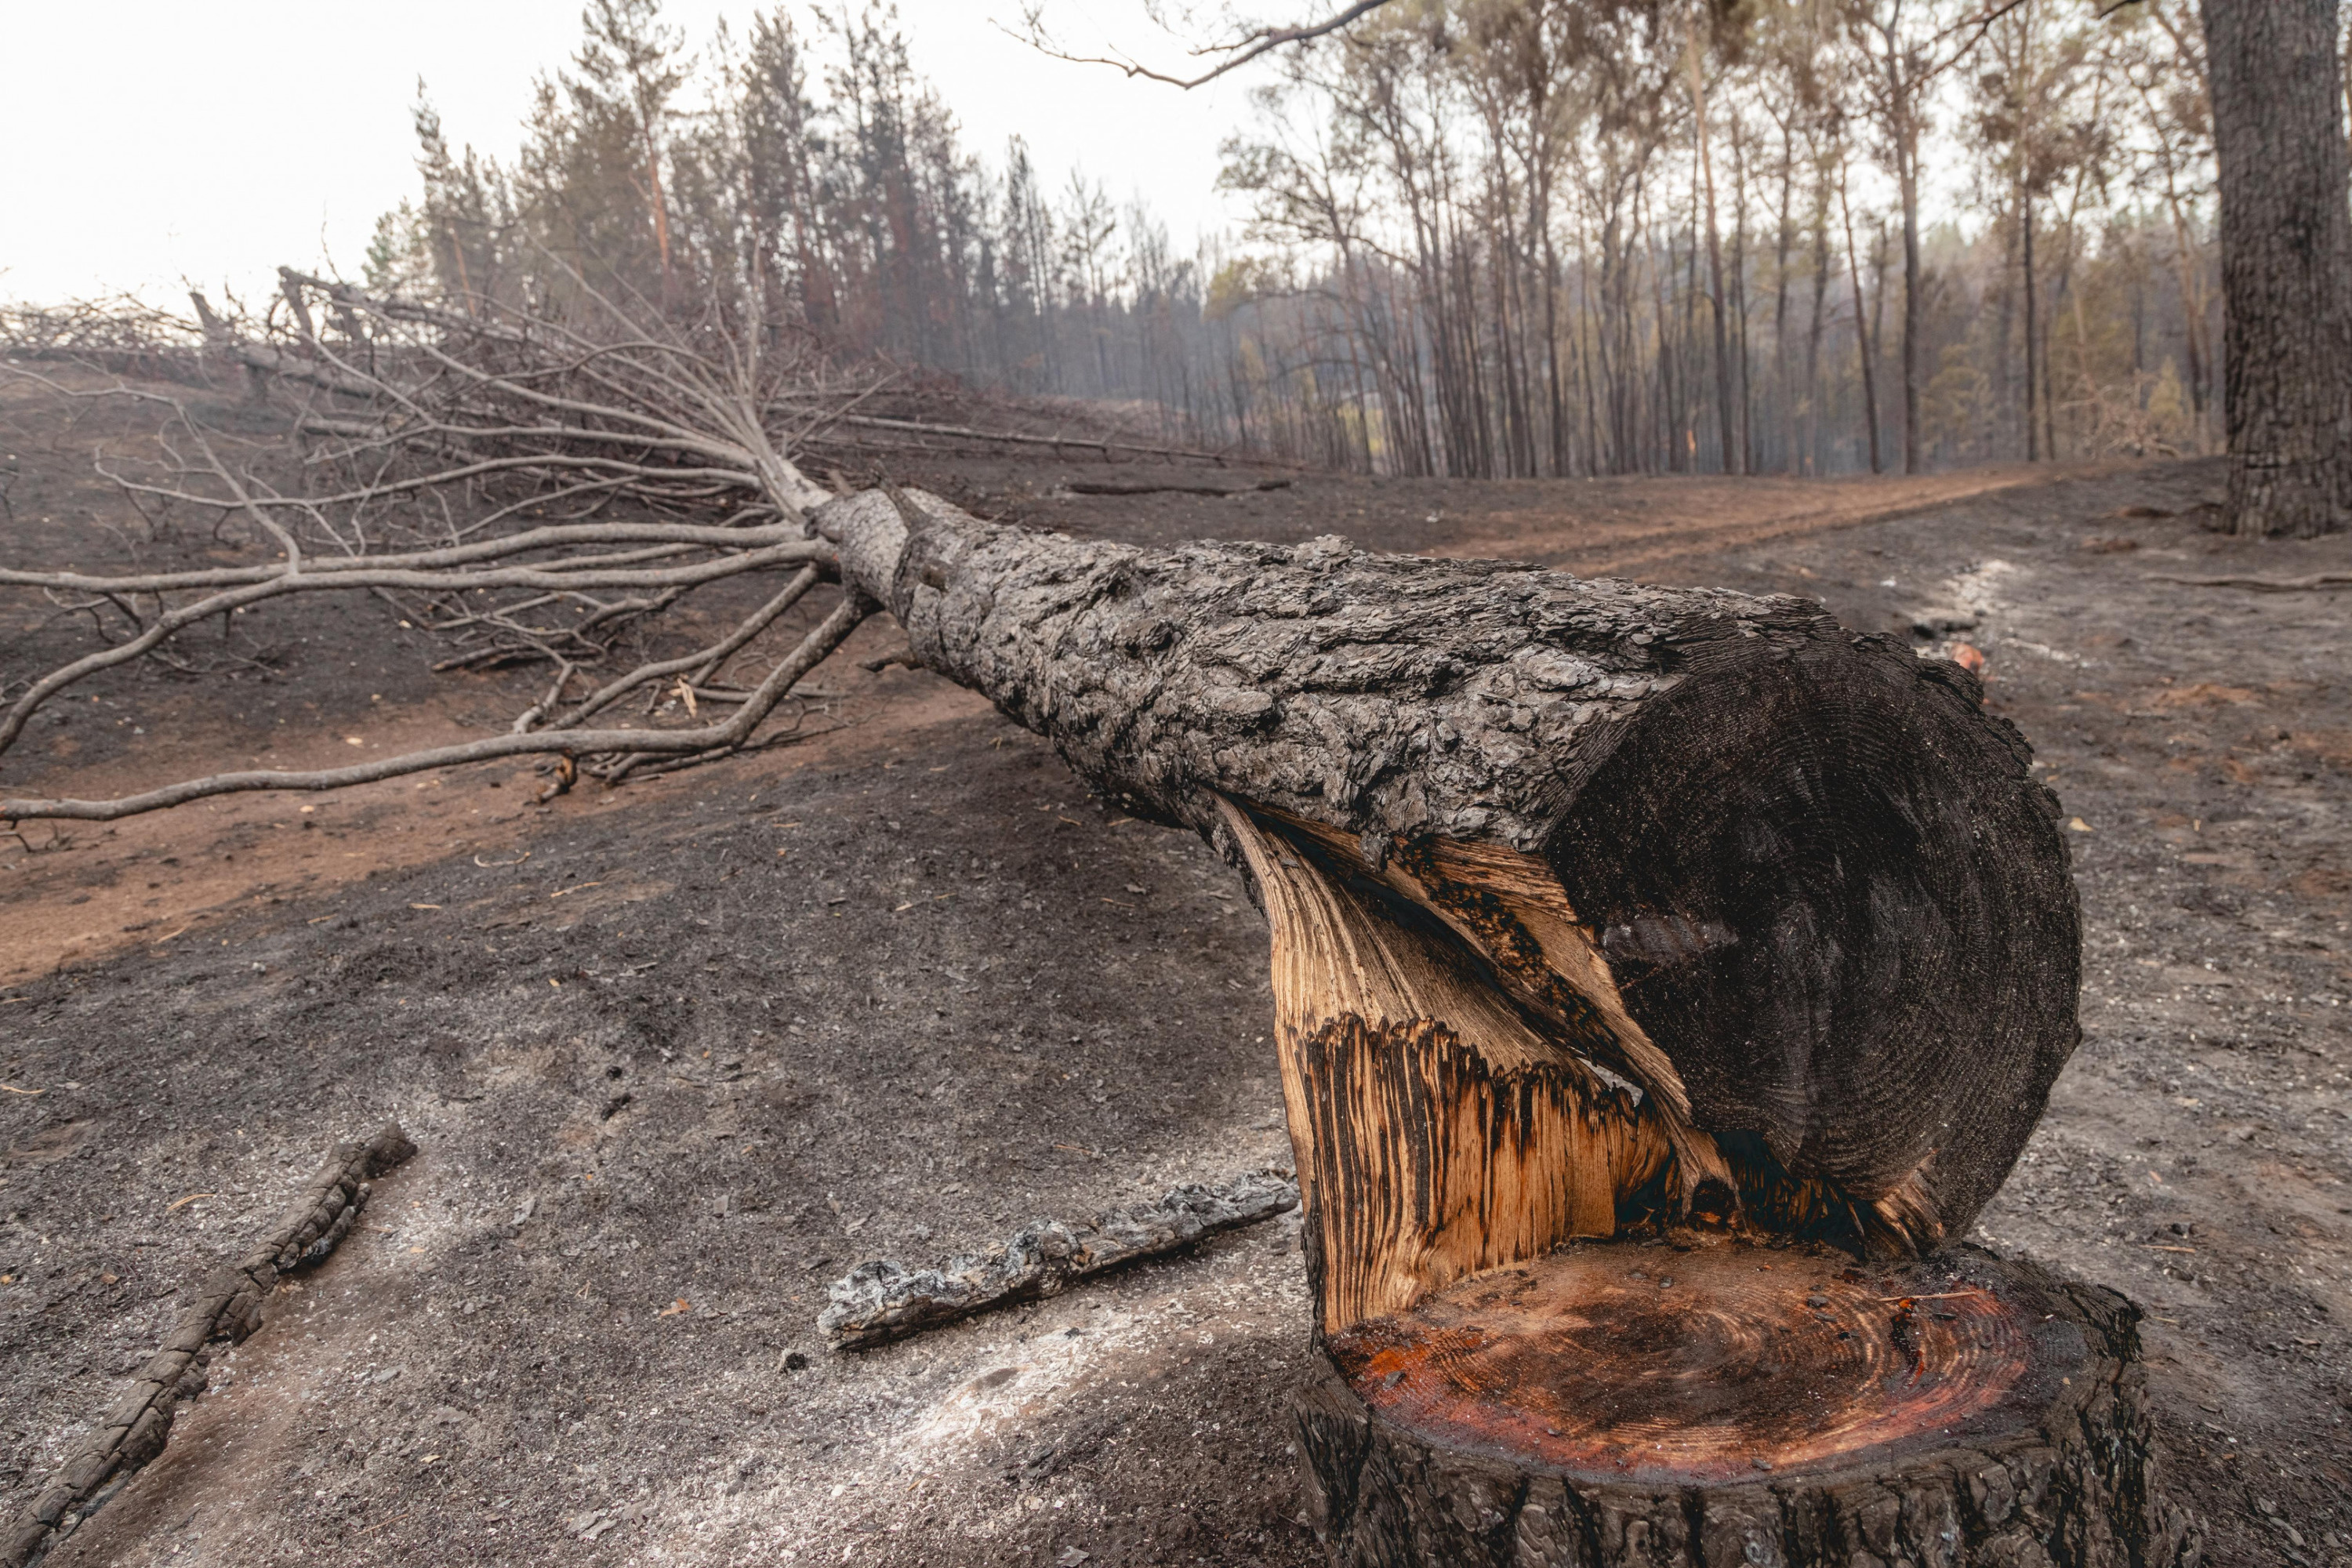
[{"left": 2199, "top": 0, "right": 2352, "bottom": 539}]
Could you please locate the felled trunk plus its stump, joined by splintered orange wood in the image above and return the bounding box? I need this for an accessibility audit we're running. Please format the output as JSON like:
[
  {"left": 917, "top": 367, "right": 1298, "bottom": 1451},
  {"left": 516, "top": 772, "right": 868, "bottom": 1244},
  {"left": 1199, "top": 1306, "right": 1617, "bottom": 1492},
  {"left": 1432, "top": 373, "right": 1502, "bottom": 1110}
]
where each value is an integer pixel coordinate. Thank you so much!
[{"left": 816, "top": 492, "right": 2187, "bottom": 1568}]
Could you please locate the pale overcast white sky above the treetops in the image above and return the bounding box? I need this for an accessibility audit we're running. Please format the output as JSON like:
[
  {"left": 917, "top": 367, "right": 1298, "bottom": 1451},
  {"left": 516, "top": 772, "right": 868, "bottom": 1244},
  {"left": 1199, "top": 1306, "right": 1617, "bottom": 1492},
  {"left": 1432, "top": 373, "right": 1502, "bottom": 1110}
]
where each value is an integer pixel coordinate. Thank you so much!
[{"left": 0, "top": 0, "right": 1247, "bottom": 306}]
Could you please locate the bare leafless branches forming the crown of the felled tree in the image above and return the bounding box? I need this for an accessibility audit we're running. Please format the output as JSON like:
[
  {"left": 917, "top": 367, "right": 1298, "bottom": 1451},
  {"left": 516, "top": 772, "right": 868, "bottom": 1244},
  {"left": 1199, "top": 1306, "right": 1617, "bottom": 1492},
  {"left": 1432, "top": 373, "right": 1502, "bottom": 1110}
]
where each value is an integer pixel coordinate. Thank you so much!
[{"left": 0, "top": 270, "right": 908, "bottom": 820}]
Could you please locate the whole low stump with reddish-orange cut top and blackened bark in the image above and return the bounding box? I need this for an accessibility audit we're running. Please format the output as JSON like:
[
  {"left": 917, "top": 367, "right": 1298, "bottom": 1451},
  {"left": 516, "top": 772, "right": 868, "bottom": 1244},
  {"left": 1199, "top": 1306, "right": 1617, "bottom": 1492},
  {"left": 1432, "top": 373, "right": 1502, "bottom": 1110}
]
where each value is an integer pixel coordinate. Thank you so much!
[{"left": 1296, "top": 1241, "right": 2194, "bottom": 1568}]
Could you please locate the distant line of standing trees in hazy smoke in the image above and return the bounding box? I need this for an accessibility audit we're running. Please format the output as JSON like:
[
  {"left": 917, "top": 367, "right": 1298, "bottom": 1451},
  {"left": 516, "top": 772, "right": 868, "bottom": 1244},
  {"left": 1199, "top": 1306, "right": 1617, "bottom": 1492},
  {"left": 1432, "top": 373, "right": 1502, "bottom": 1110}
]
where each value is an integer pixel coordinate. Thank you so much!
[{"left": 367, "top": 0, "right": 2220, "bottom": 475}]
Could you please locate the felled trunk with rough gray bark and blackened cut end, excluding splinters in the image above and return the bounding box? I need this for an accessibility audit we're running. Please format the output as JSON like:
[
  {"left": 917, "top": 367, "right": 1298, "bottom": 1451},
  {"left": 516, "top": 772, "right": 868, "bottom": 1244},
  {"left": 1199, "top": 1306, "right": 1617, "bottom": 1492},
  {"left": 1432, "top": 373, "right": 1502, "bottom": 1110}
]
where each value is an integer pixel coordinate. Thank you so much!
[{"left": 816, "top": 494, "right": 2077, "bottom": 1241}]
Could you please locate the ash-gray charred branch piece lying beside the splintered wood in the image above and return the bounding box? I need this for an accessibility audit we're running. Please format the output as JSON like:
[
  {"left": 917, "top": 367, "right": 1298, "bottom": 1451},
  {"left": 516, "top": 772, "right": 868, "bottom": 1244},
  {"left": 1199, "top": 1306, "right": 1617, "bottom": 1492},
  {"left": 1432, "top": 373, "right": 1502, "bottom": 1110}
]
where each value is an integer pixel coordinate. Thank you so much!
[{"left": 816, "top": 1173, "right": 1298, "bottom": 1349}]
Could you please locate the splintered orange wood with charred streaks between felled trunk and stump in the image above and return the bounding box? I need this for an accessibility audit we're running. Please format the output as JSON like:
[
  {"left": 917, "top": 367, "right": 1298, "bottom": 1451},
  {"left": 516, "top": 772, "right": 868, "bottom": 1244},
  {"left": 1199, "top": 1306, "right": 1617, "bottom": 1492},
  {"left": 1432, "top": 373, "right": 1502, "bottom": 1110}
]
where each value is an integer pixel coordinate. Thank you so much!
[{"left": 1225, "top": 804, "right": 1672, "bottom": 1333}]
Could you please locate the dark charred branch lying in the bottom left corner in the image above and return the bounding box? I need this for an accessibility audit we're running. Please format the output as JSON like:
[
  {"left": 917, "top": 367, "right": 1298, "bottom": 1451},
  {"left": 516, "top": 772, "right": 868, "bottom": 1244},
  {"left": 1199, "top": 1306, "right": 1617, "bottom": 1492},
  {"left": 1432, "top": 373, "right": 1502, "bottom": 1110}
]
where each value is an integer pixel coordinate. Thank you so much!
[{"left": 0, "top": 1121, "right": 416, "bottom": 1568}]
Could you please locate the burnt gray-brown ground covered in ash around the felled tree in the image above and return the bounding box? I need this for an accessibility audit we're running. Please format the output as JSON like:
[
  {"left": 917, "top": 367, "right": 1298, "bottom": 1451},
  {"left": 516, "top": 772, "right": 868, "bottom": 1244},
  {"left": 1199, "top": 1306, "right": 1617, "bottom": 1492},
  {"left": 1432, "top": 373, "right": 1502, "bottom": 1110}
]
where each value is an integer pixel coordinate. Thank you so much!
[{"left": 0, "top": 392, "right": 2352, "bottom": 1568}]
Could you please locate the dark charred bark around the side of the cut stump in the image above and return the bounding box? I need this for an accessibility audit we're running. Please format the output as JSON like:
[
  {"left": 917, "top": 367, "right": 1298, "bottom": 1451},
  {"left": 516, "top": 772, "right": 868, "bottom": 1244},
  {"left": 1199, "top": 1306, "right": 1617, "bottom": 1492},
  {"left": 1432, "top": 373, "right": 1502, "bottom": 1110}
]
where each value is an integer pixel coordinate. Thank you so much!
[{"left": 1294, "top": 1246, "right": 2197, "bottom": 1568}]
